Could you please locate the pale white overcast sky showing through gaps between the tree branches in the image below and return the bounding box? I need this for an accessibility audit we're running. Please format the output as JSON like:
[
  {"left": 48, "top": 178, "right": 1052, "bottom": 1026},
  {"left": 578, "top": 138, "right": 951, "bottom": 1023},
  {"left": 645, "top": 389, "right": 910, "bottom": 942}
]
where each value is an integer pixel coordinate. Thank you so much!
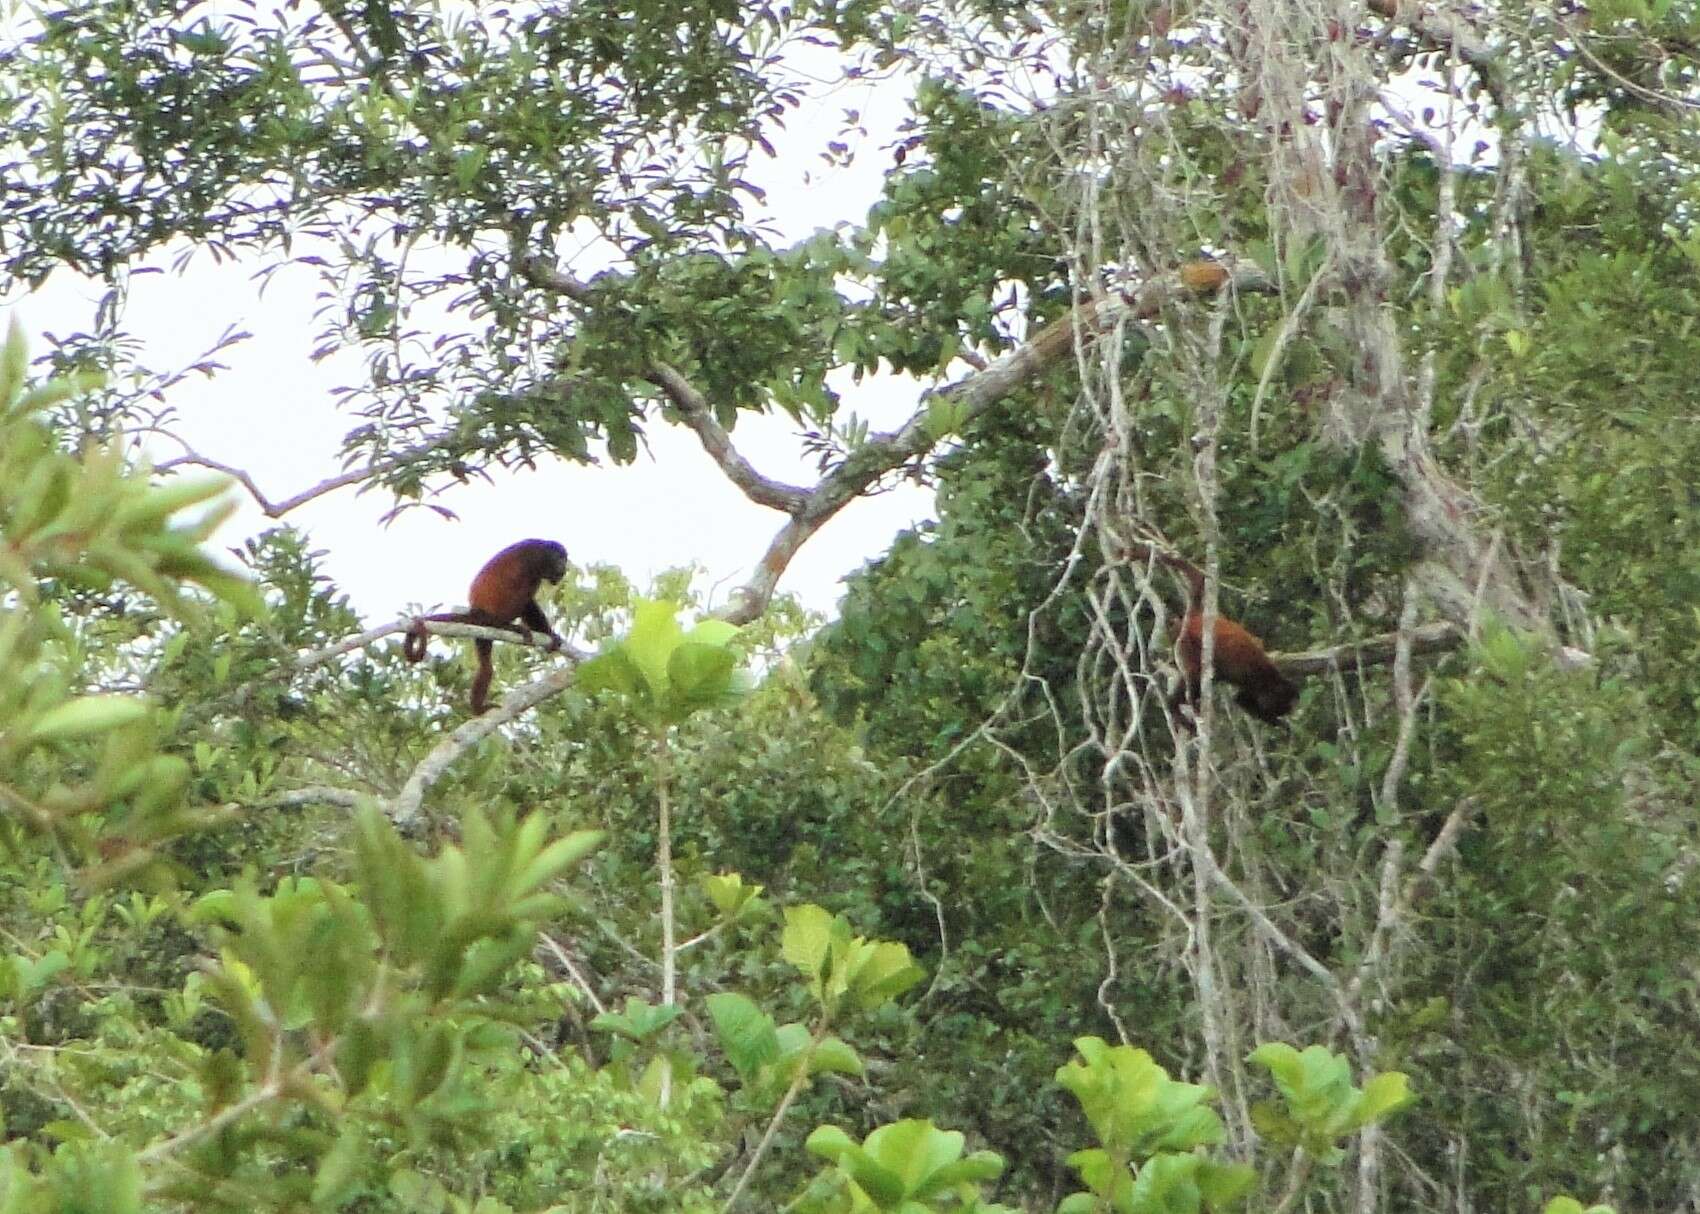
[{"left": 3, "top": 40, "right": 932, "bottom": 622}]
